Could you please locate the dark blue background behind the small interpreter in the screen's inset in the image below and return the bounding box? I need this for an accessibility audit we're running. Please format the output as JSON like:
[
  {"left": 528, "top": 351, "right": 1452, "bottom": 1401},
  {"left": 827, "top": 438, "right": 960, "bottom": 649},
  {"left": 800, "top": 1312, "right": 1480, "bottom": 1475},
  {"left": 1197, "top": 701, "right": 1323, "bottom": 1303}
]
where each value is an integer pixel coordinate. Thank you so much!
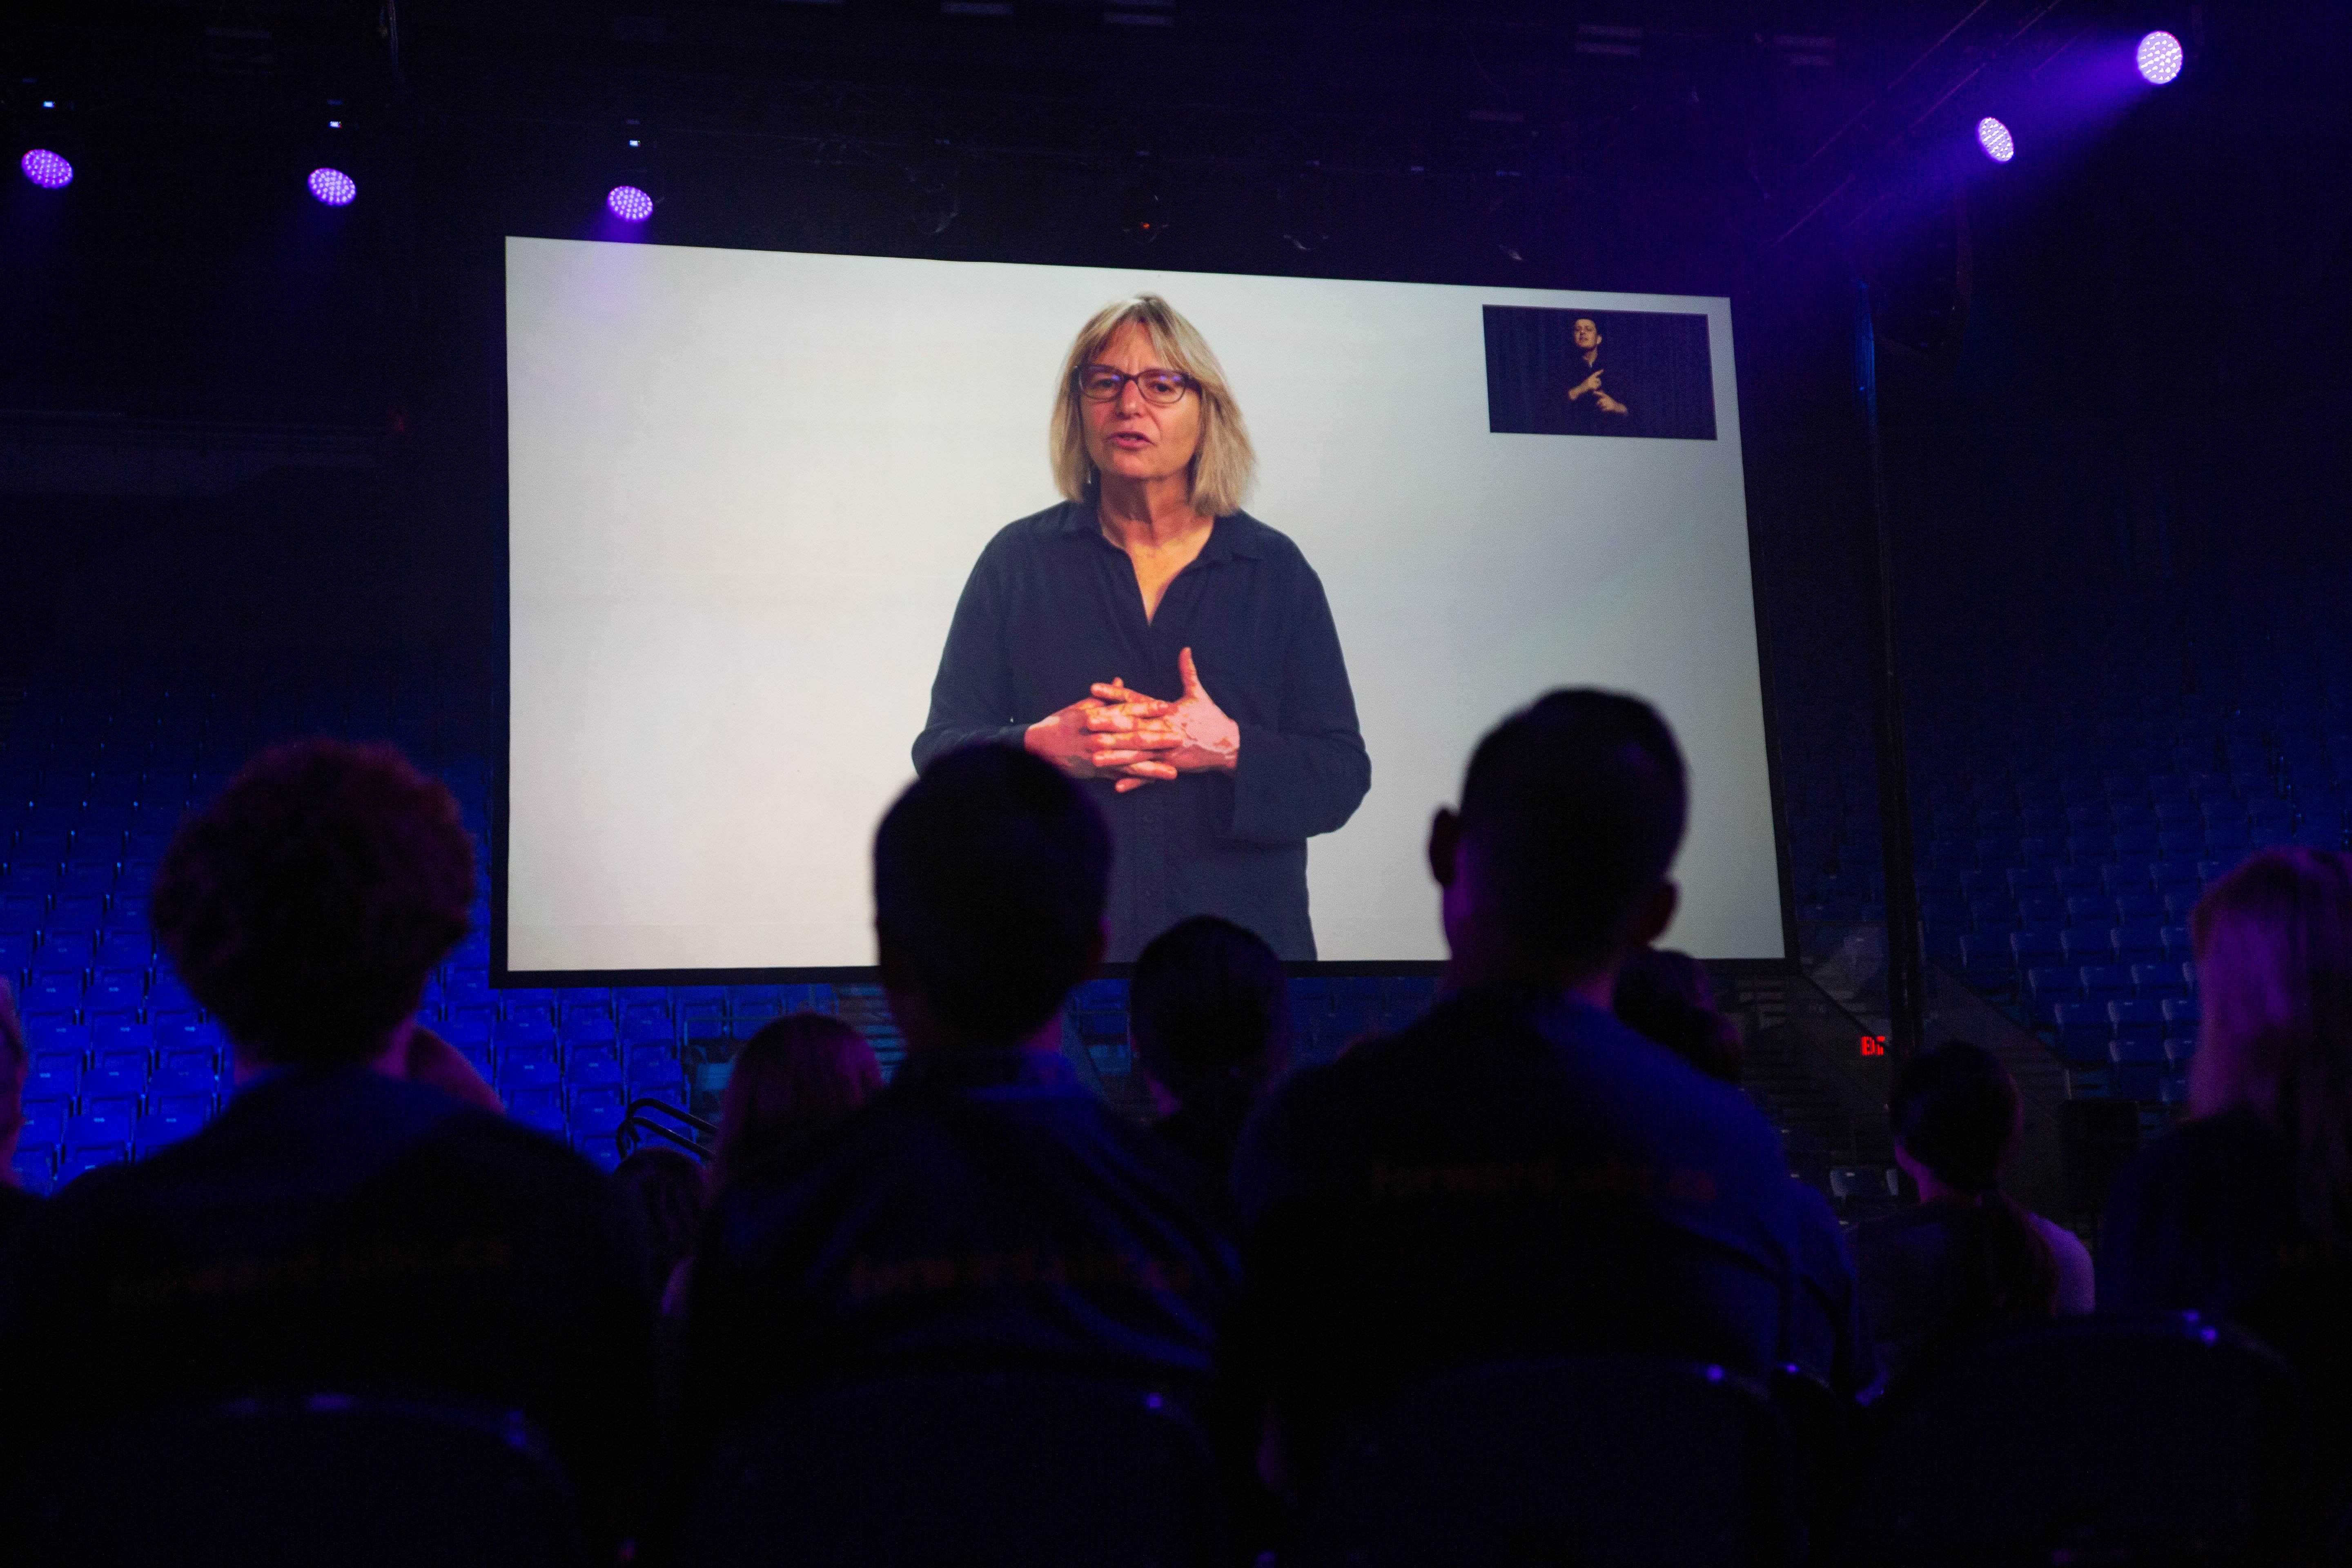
[{"left": 1486, "top": 305, "right": 1715, "bottom": 442}]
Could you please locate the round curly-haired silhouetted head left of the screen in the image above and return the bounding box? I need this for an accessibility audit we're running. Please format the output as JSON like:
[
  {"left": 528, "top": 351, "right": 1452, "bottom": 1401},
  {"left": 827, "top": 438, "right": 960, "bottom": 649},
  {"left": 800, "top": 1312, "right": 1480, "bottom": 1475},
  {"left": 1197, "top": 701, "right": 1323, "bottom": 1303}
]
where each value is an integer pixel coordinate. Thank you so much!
[{"left": 148, "top": 740, "right": 473, "bottom": 1067}]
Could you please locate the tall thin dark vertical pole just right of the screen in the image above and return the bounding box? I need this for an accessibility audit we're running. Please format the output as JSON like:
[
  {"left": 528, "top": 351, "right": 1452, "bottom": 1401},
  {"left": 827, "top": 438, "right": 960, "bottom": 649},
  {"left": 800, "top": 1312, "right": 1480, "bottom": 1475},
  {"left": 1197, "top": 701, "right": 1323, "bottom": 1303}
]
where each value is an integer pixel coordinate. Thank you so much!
[{"left": 1853, "top": 275, "right": 1926, "bottom": 1065}]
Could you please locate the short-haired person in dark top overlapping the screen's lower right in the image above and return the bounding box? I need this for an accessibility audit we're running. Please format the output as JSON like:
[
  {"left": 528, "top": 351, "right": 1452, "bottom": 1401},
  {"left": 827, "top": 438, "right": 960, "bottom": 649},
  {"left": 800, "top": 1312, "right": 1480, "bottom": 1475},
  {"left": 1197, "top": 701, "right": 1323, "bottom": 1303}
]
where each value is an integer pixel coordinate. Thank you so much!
[{"left": 1235, "top": 691, "right": 1872, "bottom": 1490}]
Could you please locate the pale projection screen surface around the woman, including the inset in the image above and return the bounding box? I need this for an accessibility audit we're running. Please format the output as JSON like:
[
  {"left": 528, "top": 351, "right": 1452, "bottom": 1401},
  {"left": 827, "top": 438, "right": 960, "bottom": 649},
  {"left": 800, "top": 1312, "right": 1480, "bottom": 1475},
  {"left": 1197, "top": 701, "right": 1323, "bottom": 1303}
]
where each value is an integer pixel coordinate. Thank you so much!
[{"left": 501, "top": 240, "right": 1785, "bottom": 976}]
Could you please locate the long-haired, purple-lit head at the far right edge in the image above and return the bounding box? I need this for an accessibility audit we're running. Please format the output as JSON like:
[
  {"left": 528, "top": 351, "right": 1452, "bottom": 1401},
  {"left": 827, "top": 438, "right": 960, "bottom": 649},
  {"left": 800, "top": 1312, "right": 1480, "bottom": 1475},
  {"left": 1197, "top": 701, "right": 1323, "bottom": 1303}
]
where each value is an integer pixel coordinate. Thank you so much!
[{"left": 2190, "top": 849, "right": 2352, "bottom": 1255}]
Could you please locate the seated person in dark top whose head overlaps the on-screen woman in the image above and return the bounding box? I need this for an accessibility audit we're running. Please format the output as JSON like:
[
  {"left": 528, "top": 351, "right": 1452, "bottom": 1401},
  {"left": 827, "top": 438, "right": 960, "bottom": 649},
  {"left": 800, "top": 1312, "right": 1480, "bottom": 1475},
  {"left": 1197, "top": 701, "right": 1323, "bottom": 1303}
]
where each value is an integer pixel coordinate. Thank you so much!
[{"left": 684, "top": 745, "right": 1235, "bottom": 1474}]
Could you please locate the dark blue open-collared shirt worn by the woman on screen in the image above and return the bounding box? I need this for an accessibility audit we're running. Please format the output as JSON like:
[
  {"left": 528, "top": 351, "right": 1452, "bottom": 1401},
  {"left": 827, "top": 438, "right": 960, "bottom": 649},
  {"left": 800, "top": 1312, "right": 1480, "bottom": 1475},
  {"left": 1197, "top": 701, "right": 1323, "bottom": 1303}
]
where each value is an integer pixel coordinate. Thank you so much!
[{"left": 915, "top": 503, "right": 1371, "bottom": 964}]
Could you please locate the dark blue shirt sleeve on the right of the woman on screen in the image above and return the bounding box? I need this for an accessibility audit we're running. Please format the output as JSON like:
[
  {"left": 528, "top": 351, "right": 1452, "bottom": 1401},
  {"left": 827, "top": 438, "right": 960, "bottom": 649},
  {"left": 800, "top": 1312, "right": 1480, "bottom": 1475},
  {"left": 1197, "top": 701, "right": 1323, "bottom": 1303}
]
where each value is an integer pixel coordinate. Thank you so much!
[{"left": 1223, "top": 562, "right": 1371, "bottom": 844}]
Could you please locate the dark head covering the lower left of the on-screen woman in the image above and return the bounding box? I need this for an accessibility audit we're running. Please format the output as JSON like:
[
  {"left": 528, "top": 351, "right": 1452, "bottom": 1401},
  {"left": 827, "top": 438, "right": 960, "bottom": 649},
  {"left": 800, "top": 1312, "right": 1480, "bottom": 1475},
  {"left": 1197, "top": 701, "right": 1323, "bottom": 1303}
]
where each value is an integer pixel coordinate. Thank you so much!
[{"left": 875, "top": 745, "right": 1110, "bottom": 1049}]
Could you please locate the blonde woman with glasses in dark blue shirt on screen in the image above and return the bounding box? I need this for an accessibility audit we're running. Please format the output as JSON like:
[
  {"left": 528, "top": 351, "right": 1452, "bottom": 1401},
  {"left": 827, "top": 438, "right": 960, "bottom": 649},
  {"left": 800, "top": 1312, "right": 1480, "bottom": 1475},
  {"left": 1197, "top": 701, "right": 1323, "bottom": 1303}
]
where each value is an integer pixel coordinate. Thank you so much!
[{"left": 915, "top": 294, "right": 1371, "bottom": 964}]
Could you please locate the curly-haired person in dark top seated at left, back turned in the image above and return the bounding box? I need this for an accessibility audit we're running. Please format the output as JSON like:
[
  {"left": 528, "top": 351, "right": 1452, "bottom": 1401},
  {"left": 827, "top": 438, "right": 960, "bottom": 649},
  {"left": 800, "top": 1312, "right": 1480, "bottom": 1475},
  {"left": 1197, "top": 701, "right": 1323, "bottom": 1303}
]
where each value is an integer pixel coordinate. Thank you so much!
[{"left": 0, "top": 740, "right": 654, "bottom": 1556}]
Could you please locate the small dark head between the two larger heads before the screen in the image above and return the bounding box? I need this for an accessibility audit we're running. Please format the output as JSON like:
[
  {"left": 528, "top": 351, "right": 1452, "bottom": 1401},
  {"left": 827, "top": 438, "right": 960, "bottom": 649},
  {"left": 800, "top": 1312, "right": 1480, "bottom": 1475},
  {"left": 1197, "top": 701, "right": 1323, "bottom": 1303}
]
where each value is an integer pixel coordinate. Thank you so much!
[{"left": 1127, "top": 915, "right": 1291, "bottom": 1102}]
